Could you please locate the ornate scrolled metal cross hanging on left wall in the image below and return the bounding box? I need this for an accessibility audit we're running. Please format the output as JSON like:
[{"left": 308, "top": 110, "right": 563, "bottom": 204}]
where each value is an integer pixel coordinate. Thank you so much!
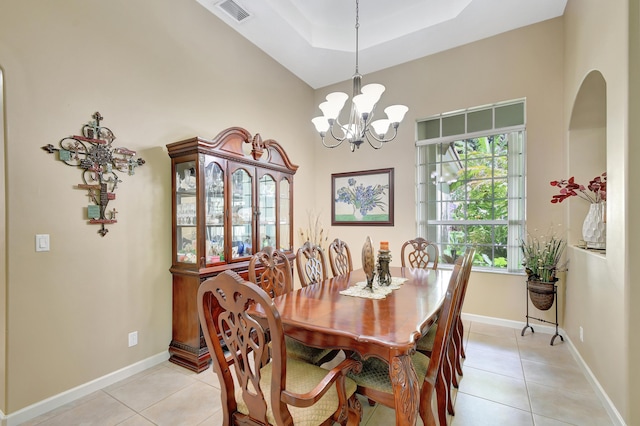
[{"left": 42, "top": 112, "right": 145, "bottom": 237}]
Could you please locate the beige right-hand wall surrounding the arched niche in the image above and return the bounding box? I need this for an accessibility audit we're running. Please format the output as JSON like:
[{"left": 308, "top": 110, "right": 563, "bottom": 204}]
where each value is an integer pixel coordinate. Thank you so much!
[{"left": 563, "top": 0, "right": 628, "bottom": 424}]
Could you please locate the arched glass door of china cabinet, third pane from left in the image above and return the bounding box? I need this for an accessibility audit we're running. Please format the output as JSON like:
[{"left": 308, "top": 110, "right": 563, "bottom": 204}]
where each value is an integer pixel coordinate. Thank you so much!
[{"left": 231, "top": 169, "right": 253, "bottom": 259}]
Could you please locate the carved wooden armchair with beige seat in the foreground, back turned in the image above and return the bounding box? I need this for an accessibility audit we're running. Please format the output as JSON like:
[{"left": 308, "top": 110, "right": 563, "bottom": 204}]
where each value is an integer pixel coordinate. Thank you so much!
[{"left": 197, "top": 271, "right": 362, "bottom": 425}]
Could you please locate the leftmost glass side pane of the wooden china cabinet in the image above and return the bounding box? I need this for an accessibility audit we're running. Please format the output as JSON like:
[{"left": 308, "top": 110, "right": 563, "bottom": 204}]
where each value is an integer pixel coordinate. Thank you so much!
[{"left": 174, "top": 160, "right": 198, "bottom": 264}]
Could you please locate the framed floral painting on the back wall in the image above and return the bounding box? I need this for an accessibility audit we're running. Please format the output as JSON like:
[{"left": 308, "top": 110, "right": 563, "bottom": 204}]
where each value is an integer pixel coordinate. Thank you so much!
[{"left": 331, "top": 169, "right": 393, "bottom": 226}]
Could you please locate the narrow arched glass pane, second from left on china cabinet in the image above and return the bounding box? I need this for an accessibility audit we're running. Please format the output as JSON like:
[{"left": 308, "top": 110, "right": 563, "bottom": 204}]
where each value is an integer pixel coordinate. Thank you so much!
[{"left": 206, "top": 155, "right": 225, "bottom": 265}]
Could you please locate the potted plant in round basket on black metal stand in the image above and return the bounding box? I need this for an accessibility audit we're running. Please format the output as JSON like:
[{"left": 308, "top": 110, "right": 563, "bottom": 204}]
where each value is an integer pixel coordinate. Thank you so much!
[{"left": 520, "top": 235, "right": 567, "bottom": 311}]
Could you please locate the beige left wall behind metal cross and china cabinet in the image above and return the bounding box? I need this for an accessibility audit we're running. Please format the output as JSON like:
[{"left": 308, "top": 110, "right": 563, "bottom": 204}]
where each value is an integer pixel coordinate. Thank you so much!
[{"left": 0, "top": 0, "right": 314, "bottom": 414}]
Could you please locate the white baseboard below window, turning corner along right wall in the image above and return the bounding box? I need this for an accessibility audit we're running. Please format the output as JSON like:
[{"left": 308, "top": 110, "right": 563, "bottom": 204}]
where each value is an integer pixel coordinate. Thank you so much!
[{"left": 461, "top": 313, "right": 626, "bottom": 426}]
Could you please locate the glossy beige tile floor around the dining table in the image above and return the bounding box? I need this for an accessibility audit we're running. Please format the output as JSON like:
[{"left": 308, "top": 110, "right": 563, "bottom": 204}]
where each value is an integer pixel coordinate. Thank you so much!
[{"left": 23, "top": 322, "right": 613, "bottom": 426}]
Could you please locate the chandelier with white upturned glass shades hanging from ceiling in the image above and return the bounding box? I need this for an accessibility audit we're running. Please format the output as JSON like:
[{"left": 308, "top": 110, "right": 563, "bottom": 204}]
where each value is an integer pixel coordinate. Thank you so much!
[{"left": 311, "top": 0, "right": 409, "bottom": 152}]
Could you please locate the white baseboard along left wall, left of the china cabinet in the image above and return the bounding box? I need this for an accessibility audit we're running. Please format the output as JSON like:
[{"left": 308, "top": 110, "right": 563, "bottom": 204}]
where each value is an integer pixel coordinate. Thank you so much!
[{"left": 0, "top": 351, "right": 169, "bottom": 426}]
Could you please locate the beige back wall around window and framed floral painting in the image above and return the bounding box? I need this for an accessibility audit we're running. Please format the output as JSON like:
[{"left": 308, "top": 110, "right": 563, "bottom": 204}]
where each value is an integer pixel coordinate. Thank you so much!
[{"left": 315, "top": 18, "right": 565, "bottom": 321}]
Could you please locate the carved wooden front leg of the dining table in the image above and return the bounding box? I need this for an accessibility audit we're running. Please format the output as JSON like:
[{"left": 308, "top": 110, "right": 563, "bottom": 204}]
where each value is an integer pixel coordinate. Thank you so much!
[{"left": 389, "top": 355, "right": 420, "bottom": 426}]
